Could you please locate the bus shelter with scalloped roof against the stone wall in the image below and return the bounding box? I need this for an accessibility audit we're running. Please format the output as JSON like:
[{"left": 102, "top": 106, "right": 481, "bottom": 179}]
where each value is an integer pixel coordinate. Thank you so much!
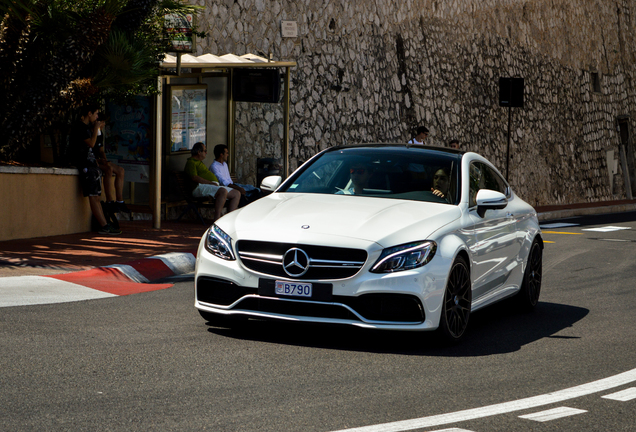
[{"left": 149, "top": 54, "right": 296, "bottom": 228}]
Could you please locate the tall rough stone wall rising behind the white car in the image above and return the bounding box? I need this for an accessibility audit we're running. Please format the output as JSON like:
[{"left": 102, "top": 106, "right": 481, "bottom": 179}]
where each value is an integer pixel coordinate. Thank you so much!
[{"left": 197, "top": 0, "right": 636, "bottom": 205}]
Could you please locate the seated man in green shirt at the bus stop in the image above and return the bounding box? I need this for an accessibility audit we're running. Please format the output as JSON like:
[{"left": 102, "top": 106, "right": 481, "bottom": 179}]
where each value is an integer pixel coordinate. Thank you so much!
[{"left": 183, "top": 142, "right": 241, "bottom": 220}]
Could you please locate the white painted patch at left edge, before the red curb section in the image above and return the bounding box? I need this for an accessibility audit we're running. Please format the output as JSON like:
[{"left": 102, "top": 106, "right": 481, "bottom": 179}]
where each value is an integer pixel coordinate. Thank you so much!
[{"left": 0, "top": 276, "right": 117, "bottom": 307}]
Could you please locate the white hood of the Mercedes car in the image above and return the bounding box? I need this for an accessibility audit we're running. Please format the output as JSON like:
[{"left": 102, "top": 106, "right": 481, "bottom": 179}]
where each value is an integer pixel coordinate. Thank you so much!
[{"left": 217, "top": 193, "right": 460, "bottom": 247}]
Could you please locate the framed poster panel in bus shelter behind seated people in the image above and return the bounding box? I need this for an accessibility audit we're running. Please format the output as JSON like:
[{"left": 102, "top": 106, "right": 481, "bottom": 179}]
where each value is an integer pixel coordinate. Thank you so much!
[{"left": 170, "top": 85, "right": 207, "bottom": 153}]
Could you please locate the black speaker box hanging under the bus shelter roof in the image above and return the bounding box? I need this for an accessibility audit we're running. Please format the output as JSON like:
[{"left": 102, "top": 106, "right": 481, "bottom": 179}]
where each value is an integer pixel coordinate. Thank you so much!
[{"left": 232, "top": 68, "right": 281, "bottom": 103}]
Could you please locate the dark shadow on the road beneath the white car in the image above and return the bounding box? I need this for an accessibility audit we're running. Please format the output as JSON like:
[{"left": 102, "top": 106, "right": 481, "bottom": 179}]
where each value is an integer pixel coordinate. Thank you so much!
[{"left": 208, "top": 301, "right": 589, "bottom": 357}]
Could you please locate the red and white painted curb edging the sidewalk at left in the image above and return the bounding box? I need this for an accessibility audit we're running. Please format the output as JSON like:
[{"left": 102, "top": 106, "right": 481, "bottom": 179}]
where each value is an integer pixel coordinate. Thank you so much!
[{"left": 0, "top": 252, "right": 196, "bottom": 307}]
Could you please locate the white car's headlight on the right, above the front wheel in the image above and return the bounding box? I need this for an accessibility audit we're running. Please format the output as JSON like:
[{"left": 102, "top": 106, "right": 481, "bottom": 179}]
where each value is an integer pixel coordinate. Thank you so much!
[{"left": 371, "top": 241, "right": 437, "bottom": 273}]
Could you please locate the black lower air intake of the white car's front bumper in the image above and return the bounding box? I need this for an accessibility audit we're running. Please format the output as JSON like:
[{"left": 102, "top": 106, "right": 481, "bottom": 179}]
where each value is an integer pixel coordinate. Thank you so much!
[{"left": 197, "top": 277, "right": 425, "bottom": 323}]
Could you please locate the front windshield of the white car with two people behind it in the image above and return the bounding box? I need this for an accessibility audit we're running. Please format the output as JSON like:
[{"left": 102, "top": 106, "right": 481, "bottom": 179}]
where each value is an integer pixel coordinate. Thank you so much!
[{"left": 280, "top": 146, "right": 461, "bottom": 204}]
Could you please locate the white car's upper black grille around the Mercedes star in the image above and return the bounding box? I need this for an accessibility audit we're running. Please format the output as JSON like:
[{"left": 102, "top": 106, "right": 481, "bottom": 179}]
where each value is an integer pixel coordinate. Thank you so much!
[{"left": 237, "top": 240, "right": 367, "bottom": 280}]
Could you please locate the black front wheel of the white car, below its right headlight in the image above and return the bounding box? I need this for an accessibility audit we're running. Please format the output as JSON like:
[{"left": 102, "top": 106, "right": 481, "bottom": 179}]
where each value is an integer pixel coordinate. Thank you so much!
[{"left": 439, "top": 256, "right": 472, "bottom": 342}]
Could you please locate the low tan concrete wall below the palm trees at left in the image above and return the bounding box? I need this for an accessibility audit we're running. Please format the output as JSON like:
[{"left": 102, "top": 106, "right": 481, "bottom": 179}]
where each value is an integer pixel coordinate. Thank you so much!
[{"left": 0, "top": 167, "right": 91, "bottom": 241}]
